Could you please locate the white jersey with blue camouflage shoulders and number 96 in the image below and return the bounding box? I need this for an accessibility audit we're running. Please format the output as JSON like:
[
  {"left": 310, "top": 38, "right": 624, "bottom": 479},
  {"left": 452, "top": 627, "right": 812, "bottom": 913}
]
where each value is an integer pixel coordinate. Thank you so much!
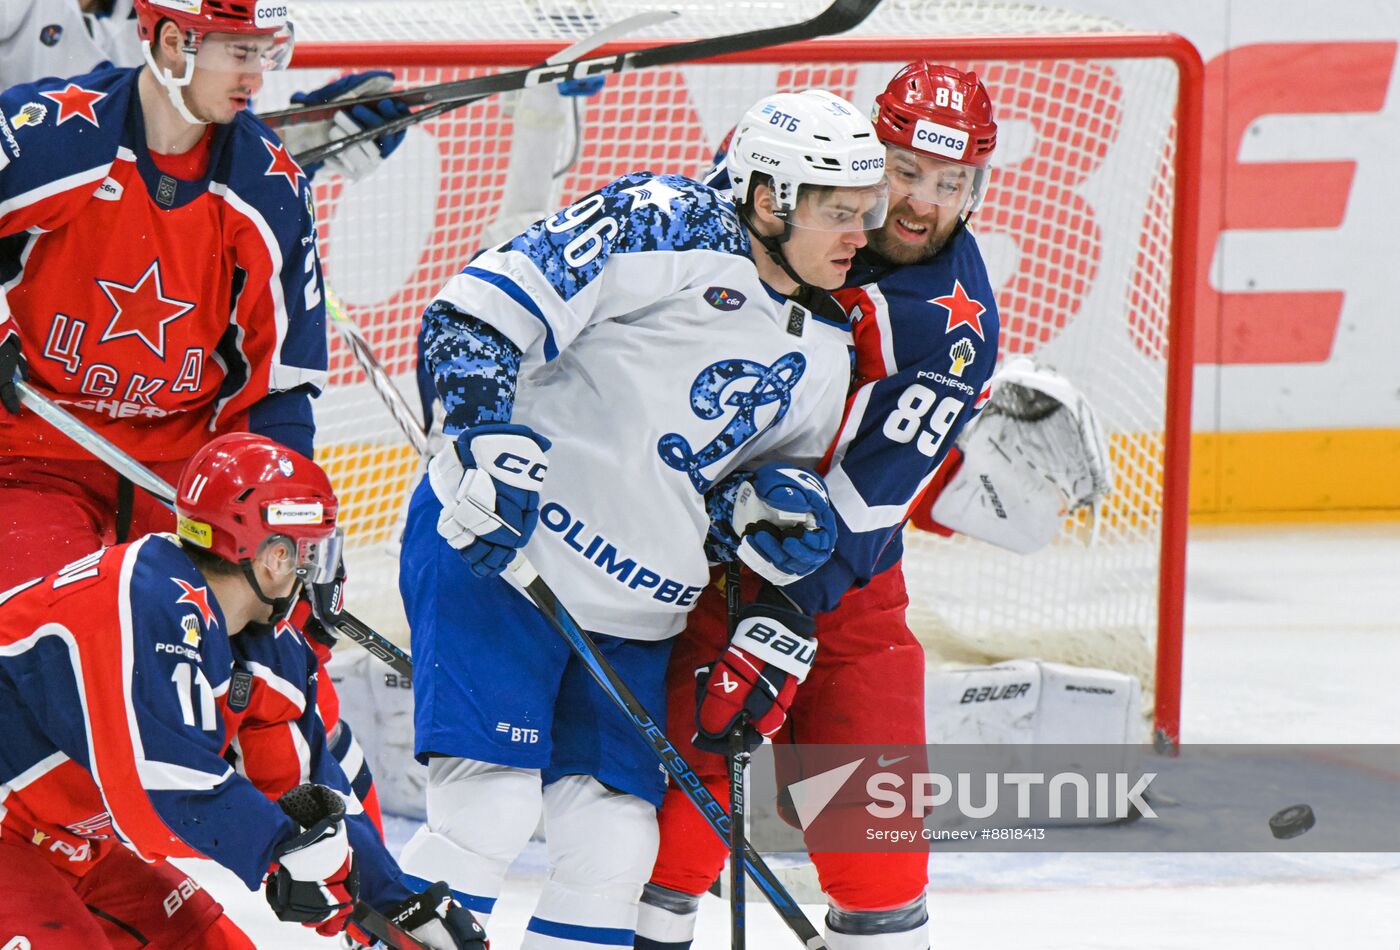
[{"left": 438, "top": 173, "right": 851, "bottom": 639}]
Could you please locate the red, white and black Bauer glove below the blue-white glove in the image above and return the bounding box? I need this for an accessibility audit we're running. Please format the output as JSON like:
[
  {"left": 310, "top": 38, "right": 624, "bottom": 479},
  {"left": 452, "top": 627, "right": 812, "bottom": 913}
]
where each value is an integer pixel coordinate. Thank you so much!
[{"left": 694, "top": 603, "right": 816, "bottom": 754}]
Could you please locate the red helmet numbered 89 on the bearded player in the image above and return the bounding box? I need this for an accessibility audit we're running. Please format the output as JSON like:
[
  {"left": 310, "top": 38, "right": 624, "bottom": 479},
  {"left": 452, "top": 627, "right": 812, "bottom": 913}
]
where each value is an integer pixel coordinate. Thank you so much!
[{"left": 872, "top": 60, "right": 997, "bottom": 168}]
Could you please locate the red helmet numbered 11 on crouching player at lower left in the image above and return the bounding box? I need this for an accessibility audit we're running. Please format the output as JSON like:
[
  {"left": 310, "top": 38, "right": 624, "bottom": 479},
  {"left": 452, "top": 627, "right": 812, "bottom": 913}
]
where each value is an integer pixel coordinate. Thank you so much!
[{"left": 175, "top": 432, "right": 340, "bottom": 583}]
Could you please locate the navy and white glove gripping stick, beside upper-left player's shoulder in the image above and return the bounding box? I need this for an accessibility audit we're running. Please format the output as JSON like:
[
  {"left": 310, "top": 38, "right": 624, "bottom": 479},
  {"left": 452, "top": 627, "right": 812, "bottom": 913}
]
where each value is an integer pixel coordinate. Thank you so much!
[{"left": 281, "top": 70, "right": 412, "bottom": 182}]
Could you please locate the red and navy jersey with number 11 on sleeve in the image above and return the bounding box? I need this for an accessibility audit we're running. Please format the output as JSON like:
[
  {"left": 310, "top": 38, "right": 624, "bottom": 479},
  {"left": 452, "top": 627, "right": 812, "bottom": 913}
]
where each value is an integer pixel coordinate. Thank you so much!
[{"left": 0, "top": 534, "right": 412, "bottom": 907}]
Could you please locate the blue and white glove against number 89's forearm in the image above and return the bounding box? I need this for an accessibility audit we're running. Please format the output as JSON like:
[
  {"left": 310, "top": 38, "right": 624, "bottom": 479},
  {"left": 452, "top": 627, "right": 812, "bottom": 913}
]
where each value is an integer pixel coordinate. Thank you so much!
[{"left": 711, "top": 462, "right": 836, "bottom": 586}]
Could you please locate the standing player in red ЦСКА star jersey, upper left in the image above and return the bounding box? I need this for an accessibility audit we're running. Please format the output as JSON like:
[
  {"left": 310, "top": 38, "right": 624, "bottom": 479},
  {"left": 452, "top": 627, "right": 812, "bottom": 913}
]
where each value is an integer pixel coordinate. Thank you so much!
[{"left": 0, "top": 0, "right": 402, "bottom": 839}]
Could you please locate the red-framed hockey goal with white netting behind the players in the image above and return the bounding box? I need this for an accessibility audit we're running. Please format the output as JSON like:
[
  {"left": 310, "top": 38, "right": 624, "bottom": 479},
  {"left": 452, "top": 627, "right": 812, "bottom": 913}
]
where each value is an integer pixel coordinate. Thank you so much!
[{"left": 260, "top": 0, "right": 1198, "bottom": 737}]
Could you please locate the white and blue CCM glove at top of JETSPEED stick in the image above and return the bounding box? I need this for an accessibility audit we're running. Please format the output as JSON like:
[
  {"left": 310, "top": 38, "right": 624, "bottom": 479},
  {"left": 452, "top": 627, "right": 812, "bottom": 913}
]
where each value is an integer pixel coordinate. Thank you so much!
[{"left": 428, "top": 424, "right": 549, "bottom": 578}]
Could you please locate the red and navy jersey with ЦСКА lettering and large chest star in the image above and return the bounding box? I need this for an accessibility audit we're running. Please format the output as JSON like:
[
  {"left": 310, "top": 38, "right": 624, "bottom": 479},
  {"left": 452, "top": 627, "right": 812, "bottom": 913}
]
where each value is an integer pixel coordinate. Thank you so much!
[{"left": 0, "top": 70, "right": 326, "bottom": 462}]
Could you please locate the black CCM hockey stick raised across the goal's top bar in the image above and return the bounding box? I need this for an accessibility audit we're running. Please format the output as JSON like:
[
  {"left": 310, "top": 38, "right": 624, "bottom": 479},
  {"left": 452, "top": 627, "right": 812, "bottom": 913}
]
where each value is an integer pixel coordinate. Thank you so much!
[{"left": 258, "top": 0, "right": 881, "bottom": 164}]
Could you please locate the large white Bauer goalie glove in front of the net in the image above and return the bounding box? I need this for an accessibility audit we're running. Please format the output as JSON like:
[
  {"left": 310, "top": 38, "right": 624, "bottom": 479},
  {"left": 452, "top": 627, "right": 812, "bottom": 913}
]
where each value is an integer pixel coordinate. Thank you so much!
[{"left": 930, "top": 357, "right": 1113, "bottom": 554}]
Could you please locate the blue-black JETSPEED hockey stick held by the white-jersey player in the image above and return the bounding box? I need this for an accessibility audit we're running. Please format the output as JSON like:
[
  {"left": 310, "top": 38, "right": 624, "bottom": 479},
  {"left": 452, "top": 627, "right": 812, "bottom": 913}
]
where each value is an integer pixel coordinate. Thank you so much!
[{"left": 312, "top": 305, "right": 826, "bottom": 950}]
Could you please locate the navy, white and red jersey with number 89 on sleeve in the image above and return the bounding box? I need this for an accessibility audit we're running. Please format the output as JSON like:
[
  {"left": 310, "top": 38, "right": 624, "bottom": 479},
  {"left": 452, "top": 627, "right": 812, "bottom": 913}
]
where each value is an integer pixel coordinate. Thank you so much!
[{"left": 784, "top": 228, "right": 1000, "bottom": 613}]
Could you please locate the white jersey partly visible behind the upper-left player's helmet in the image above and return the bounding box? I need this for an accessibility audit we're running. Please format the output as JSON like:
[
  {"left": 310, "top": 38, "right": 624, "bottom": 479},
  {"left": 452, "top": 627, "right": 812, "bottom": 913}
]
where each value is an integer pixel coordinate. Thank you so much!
[{"left": 0, "top": 0, "right": 143, "bottom": 90}]
